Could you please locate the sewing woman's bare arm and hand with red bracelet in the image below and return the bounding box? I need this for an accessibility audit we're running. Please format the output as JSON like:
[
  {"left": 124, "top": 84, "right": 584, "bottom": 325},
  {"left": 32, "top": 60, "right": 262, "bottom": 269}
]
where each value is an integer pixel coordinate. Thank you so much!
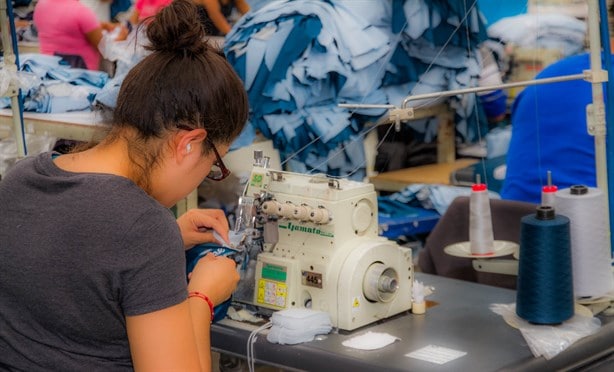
[{"left": 126, "top": 254, "right": 239, "bottom": 371}]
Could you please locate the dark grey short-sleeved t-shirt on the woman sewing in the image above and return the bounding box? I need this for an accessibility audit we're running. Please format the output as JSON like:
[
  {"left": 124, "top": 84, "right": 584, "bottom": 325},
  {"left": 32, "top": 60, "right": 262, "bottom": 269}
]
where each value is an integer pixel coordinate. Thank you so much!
[{"left": 0, "top": 153, "right": 187, "bottom": 371}]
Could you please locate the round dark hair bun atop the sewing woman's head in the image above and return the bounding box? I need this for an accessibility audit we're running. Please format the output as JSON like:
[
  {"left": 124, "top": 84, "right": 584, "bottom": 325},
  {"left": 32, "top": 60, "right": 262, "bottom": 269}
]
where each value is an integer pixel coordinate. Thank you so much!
[{"left": 147, "top": 0, "right": 207, "bottom": 54}]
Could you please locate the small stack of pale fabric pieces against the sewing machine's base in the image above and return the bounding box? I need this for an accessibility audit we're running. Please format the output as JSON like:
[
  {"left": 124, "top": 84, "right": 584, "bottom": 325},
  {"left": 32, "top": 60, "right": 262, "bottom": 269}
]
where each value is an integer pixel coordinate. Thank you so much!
[{"left": 267, "top": 308, "right": 332, "bottom": 345}]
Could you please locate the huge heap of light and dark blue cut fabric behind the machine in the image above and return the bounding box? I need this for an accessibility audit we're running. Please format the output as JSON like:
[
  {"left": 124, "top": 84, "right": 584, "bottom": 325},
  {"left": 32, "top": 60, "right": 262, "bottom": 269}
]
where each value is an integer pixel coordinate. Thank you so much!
[{"left": 225, "top": 0, "right": 486, "bottom": 179}]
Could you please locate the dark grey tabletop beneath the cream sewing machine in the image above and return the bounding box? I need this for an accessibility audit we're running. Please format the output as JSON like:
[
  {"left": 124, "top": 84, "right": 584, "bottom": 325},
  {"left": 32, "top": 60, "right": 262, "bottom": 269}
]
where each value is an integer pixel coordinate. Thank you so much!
[{"left": 211, "top": 273, "right": 614, "bottom": 371}]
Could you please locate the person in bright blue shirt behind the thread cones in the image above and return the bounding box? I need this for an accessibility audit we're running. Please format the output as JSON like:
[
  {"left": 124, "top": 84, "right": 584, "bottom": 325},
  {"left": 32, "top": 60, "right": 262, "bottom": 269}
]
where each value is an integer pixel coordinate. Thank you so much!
[{"left": 501, "top": 50, "right": 608, "bottom": 203}]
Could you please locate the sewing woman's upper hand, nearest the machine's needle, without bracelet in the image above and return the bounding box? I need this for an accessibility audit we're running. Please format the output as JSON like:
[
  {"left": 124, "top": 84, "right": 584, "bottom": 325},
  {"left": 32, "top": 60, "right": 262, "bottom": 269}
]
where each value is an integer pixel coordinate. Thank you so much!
[{"left": 177, "top": 209, "right": 229, "bottom": 249}]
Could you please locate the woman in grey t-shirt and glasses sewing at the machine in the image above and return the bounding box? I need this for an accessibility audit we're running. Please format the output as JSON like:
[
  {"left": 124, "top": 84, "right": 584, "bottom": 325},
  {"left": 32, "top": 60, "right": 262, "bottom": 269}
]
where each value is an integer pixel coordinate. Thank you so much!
[{"left": 0, "top": 0, "right": 248, "bottom": 371}]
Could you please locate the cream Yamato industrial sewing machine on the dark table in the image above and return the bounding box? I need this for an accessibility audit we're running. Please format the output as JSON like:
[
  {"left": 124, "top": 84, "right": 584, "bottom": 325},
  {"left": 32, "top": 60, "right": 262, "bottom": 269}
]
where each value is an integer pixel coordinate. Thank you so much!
[{"left": 237, "top": 151, "right": 414, "bottom": 330}]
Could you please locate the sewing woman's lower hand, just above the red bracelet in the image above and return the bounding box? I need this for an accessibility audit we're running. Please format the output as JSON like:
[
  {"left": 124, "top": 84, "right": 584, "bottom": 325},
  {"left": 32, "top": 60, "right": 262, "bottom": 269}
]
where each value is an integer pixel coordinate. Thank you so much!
[{"left": 188, "top": 253, "right": 240, "bottom": 305}]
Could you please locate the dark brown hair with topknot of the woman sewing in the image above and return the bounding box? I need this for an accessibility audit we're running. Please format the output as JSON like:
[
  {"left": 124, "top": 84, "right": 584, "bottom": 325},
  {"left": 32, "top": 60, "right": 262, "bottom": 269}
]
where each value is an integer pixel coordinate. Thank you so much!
[{"left": 107, "top": 0, "right": 248, "bottom": 190}]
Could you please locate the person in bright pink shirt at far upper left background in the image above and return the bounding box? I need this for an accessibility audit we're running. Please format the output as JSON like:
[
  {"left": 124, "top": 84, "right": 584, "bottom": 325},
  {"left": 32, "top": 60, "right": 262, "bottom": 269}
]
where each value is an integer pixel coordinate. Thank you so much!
[{"left": 33, "top": 0, "right": 125, "bottom": 70}]
